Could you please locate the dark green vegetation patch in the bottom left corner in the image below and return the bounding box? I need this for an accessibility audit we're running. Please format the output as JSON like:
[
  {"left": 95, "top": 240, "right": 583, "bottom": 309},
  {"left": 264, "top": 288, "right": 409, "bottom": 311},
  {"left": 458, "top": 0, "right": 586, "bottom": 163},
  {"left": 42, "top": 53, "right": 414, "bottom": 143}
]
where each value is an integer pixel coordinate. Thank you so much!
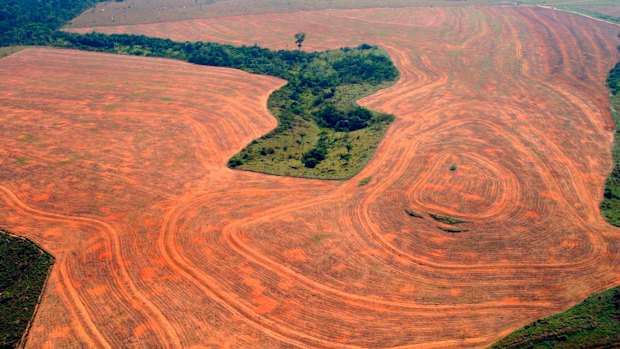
[{"left": 0, "top": 231, "right": 54, "bottom": 348}]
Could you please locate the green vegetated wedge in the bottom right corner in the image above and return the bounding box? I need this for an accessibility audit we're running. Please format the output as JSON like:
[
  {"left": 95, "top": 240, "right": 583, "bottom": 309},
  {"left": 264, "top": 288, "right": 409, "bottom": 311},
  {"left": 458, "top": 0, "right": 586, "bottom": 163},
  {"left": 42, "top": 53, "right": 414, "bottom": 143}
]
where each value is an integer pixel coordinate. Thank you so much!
[{"left": 491, "top": 287, "right": 620, "bottom": 349}]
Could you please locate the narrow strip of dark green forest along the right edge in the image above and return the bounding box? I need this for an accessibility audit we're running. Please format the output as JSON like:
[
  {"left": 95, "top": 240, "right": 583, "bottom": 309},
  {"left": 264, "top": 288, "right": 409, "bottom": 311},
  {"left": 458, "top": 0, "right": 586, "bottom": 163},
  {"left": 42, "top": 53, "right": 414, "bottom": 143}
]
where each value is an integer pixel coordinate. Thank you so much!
[{"left": 601, "top": 63, "right": 620, "bottom": 226}]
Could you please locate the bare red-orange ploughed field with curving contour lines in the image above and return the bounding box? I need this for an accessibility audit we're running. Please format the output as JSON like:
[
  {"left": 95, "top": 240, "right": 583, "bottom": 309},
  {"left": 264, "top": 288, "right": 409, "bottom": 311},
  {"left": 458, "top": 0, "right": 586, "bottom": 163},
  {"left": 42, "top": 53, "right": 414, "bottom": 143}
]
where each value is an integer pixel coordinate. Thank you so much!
[{"left": 0, "top": 8, "right": 620, "bottom": 348}]
